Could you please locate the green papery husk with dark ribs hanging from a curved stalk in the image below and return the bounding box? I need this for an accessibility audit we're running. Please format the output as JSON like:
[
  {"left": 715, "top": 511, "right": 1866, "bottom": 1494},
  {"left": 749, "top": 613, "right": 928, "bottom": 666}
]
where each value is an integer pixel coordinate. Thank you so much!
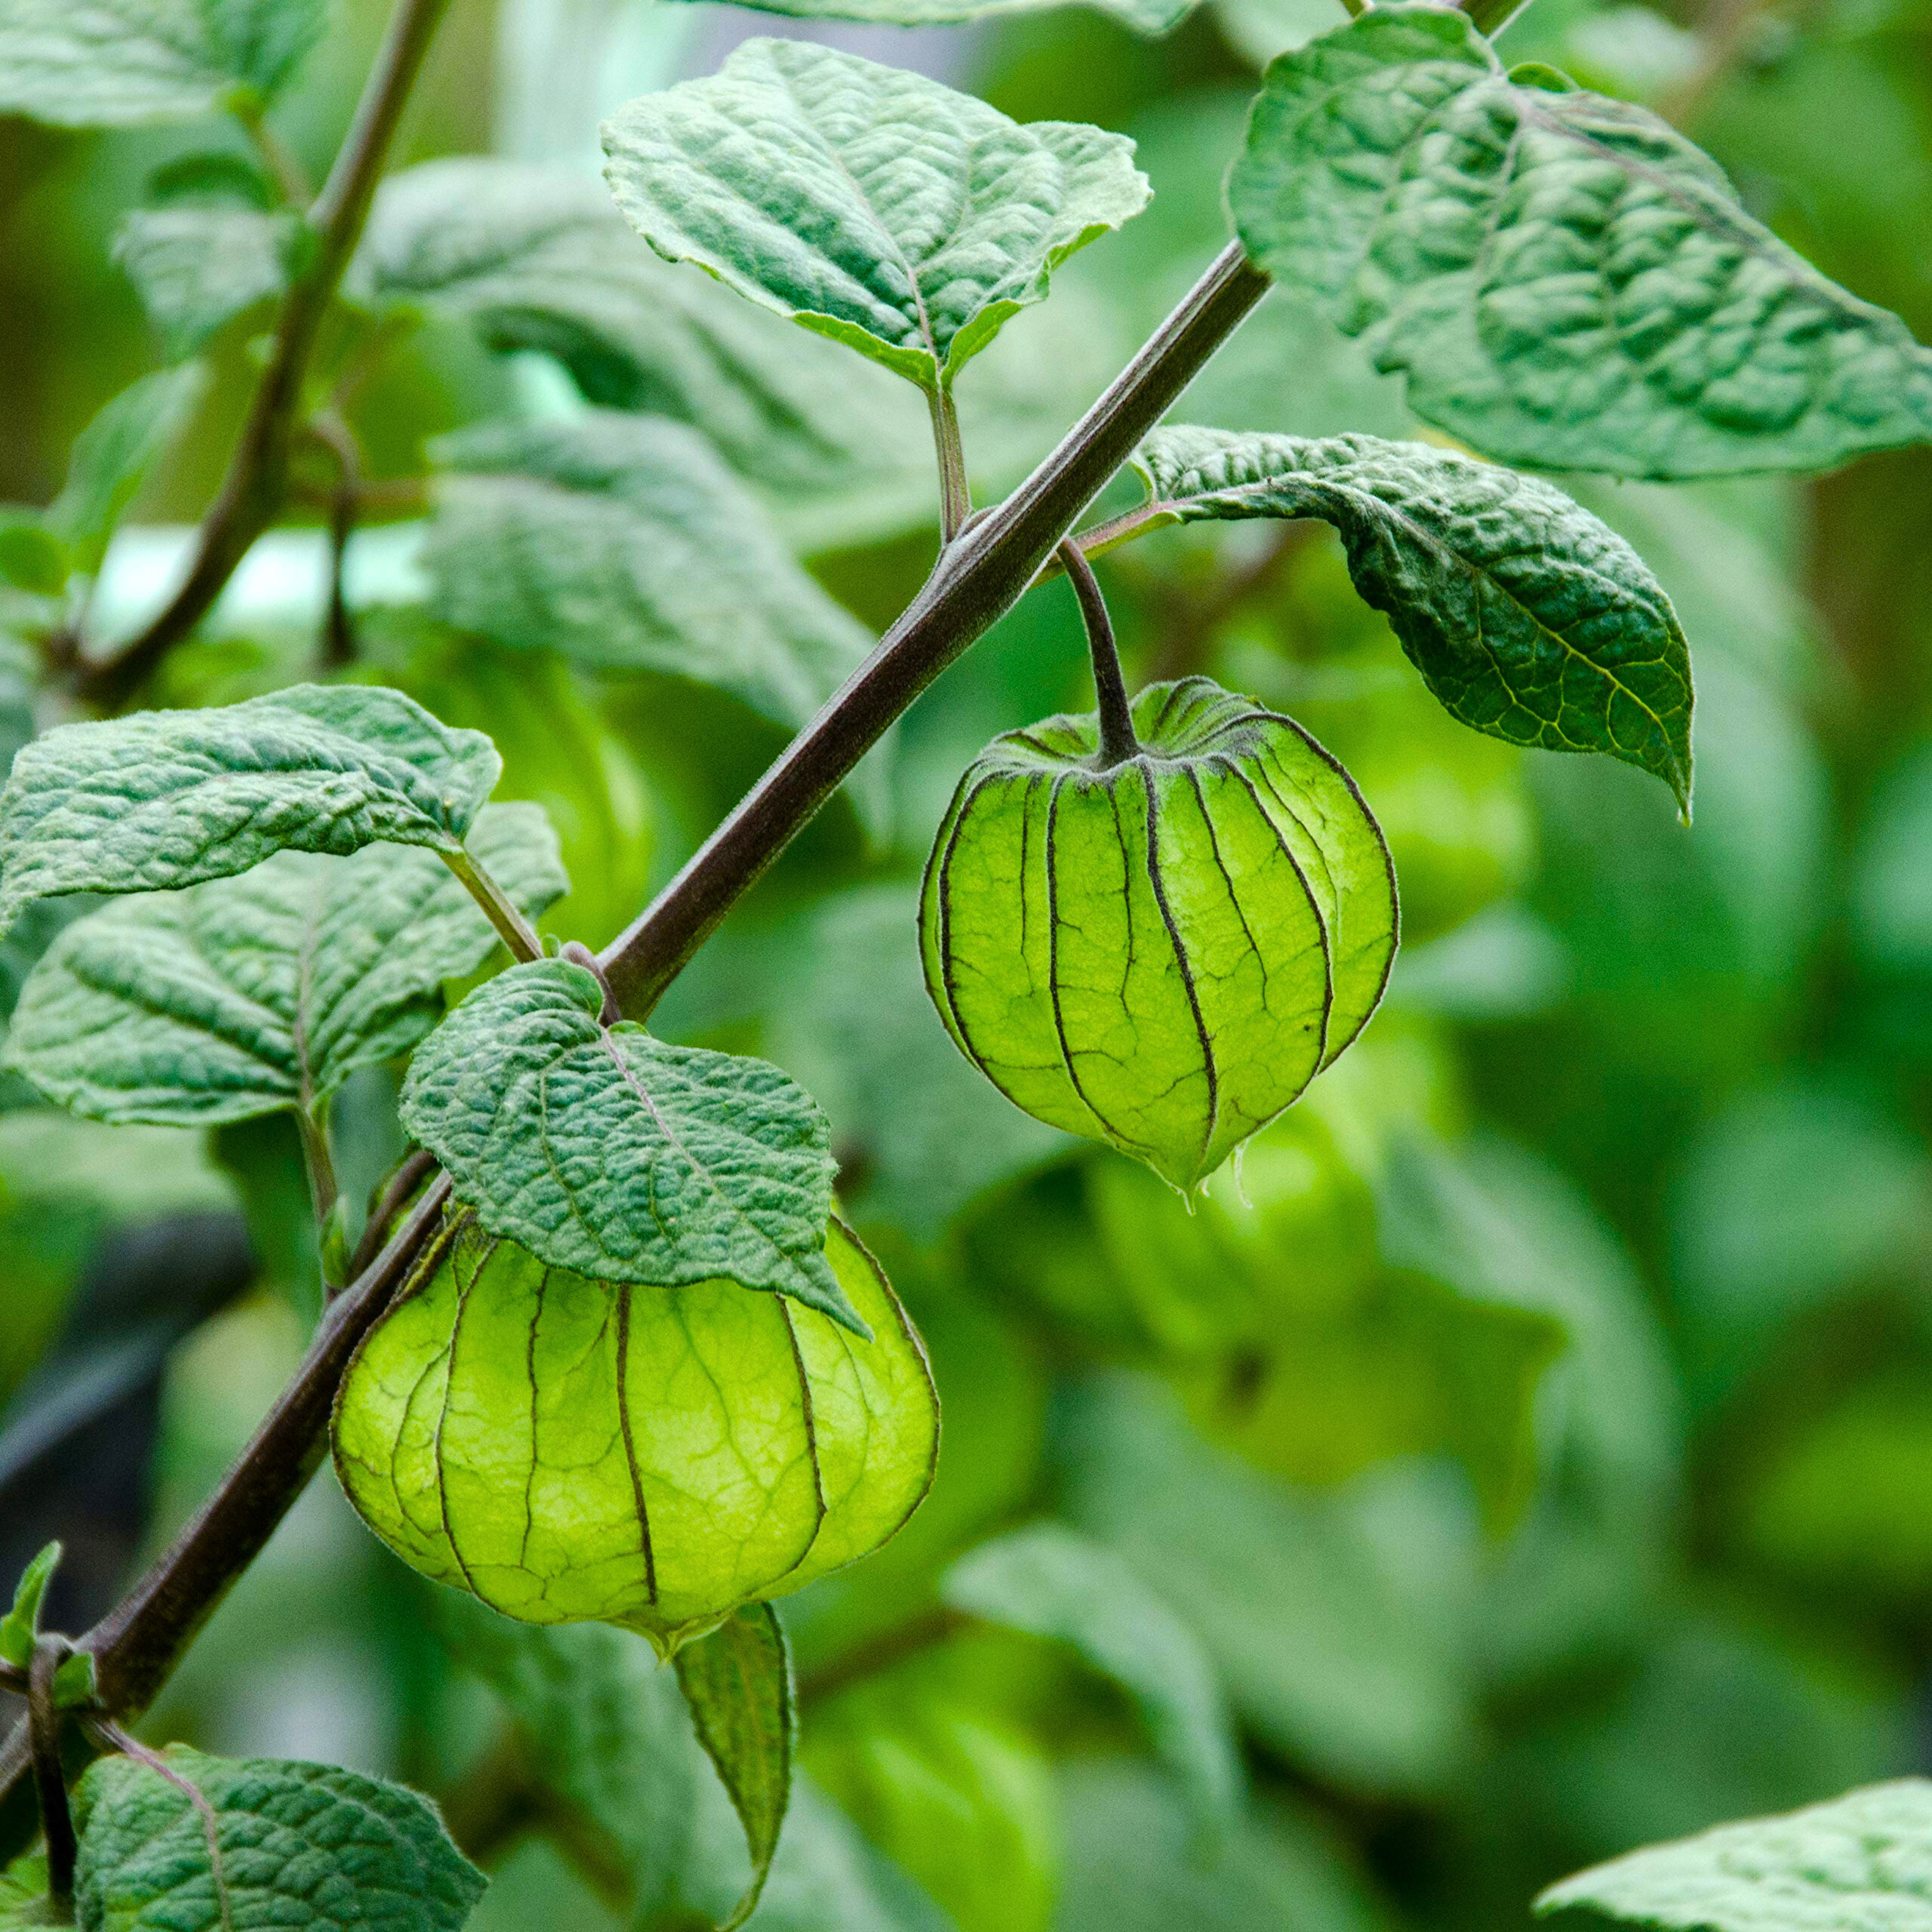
[{"left": 920, "top": 678, "right": 1397, "bottom": 1190}]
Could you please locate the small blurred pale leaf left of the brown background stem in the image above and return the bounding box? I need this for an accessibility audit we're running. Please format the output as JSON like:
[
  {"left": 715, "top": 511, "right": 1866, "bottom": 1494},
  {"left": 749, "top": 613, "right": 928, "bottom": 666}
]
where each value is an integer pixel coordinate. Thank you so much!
[{"left": 114, "top": 207, "right": 305, "bottom": 357}]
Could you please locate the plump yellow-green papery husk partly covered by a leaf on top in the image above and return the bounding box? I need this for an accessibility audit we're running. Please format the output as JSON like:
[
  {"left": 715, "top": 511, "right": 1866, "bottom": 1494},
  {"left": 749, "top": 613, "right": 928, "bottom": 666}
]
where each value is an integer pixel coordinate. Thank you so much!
[{"left": 334, "top": 1211, "right": 939, "bottom": 1656}]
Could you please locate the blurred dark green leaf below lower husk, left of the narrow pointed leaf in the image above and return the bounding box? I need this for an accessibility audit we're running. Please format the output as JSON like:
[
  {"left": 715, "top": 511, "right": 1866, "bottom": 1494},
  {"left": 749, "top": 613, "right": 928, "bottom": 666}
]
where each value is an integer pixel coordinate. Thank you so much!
[{"left": 437, "top": 1592, "right": 705, "bottom": 1922}]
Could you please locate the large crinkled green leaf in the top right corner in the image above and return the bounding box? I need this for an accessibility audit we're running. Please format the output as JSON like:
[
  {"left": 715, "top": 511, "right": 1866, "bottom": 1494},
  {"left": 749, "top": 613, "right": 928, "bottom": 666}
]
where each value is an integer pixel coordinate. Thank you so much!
[{"left": 1231, "top": 6, "right": 1932, "bottom": 479}]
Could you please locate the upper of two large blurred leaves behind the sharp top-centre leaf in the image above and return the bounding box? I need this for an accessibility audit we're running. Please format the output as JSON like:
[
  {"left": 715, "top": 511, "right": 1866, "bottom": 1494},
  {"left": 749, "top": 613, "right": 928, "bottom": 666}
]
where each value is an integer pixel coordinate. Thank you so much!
[{"left": 357, "top": 156, "right": 904, "bottom": 489}]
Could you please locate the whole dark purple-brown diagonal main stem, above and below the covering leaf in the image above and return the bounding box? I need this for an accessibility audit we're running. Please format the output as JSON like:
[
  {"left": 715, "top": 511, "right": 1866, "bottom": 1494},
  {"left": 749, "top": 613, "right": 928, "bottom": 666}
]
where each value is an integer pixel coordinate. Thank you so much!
[{"left": 0, "top": 246, "right": 1269, "bottom": 1824}]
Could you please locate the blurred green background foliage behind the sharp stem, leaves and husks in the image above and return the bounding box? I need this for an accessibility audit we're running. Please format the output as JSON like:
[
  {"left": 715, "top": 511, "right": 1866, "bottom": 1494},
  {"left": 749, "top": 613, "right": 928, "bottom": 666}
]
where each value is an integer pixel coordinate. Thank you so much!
[{"left": 0, "top": 0, "right": 1932, "bottom": 1932}]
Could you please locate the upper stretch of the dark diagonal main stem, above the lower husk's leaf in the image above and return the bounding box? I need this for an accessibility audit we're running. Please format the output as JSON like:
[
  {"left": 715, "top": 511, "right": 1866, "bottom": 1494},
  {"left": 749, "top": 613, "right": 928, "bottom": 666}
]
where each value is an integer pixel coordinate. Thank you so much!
[{"left": 603, "top": 243, "right": 1269, "bottom": 1020}]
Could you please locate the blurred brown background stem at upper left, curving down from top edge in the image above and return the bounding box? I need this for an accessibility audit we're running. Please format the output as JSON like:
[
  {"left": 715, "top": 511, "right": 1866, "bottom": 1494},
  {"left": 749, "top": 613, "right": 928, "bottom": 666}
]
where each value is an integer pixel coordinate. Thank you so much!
[{"left": 79, "top": 0, "right": 450, "bottom": 709}]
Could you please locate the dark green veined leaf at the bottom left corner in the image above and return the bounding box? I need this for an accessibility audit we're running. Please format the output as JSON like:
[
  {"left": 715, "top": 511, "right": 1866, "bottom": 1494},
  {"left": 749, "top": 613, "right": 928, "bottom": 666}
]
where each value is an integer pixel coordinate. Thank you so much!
[{"left": 73, "top": 1745, "right": 485, "bottom": 1932}]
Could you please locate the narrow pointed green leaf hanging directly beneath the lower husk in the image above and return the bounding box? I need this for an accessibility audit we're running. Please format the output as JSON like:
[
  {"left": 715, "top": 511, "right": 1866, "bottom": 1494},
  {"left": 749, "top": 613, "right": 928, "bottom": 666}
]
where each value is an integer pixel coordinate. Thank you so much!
[{"left": 676, "top": 1603, "right": 798, "bottom": 1932}]
